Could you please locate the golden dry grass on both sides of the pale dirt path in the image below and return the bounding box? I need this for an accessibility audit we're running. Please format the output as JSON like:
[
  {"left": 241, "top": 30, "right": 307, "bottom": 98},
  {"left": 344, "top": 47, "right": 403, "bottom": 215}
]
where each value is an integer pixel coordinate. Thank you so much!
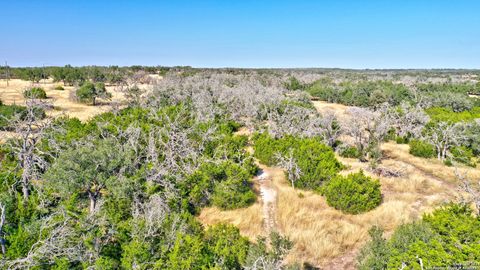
[{"left": 195, "top": 127, "right": 472, "bottom": 269}]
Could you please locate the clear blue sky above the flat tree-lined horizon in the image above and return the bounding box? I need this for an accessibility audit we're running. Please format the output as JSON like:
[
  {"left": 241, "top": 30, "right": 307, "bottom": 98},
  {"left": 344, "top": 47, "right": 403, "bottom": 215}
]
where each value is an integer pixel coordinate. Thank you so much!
[{"left": 0, "top": 0, "right": 480, "bottom": 68}]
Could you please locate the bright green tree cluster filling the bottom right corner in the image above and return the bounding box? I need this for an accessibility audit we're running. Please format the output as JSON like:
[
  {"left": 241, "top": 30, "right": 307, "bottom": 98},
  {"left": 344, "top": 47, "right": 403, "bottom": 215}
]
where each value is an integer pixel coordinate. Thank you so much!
[{"left": 358, "top": 204, "right": 480, "bottom": 270}]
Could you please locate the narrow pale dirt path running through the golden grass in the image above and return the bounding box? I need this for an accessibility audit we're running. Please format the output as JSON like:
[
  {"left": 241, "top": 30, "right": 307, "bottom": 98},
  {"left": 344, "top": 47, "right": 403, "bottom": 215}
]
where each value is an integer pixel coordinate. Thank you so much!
[{"left": 256, "top": 165, "right": 277, "bottom": 235}]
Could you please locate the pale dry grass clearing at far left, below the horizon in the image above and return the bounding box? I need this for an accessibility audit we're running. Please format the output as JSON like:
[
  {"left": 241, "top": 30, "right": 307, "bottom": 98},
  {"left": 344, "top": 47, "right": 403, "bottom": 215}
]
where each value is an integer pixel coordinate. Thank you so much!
[{"left": 0, "top": 79, "right": 123, "bottom": 121}]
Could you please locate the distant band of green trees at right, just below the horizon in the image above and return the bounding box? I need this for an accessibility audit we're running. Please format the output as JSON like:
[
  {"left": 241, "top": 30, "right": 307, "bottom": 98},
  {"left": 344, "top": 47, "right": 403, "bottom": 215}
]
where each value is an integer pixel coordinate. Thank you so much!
[{"left": 302, "top": 78, "right": 480, "bottom": 112}]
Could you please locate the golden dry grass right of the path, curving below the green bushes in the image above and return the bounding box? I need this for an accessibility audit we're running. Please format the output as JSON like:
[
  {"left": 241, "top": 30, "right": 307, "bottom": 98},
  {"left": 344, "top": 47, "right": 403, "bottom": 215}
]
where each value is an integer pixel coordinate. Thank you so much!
[{"left": 275, "top": 149, "right": 455, "bottom": 268}]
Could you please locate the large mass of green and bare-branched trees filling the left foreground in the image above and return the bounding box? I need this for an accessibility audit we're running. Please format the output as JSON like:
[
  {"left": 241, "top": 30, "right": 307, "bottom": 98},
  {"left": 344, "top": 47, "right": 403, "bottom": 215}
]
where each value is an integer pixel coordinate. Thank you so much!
[{"left": 0, "top": 97, "right": 300, "bottom": 269}]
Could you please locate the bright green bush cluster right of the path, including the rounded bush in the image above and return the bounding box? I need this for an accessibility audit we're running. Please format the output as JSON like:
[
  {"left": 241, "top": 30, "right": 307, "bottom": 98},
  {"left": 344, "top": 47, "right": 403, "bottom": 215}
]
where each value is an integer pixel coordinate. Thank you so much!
[{"left": 254, "top": 133, "right": 382, "bottom": 214}]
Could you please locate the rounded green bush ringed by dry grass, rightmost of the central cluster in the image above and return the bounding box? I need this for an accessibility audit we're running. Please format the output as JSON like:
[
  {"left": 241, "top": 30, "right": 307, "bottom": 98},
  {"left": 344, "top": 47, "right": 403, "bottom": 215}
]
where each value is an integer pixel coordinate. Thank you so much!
[{"left": 321, "top": 171, "right": 382, "bottom": 214}]
